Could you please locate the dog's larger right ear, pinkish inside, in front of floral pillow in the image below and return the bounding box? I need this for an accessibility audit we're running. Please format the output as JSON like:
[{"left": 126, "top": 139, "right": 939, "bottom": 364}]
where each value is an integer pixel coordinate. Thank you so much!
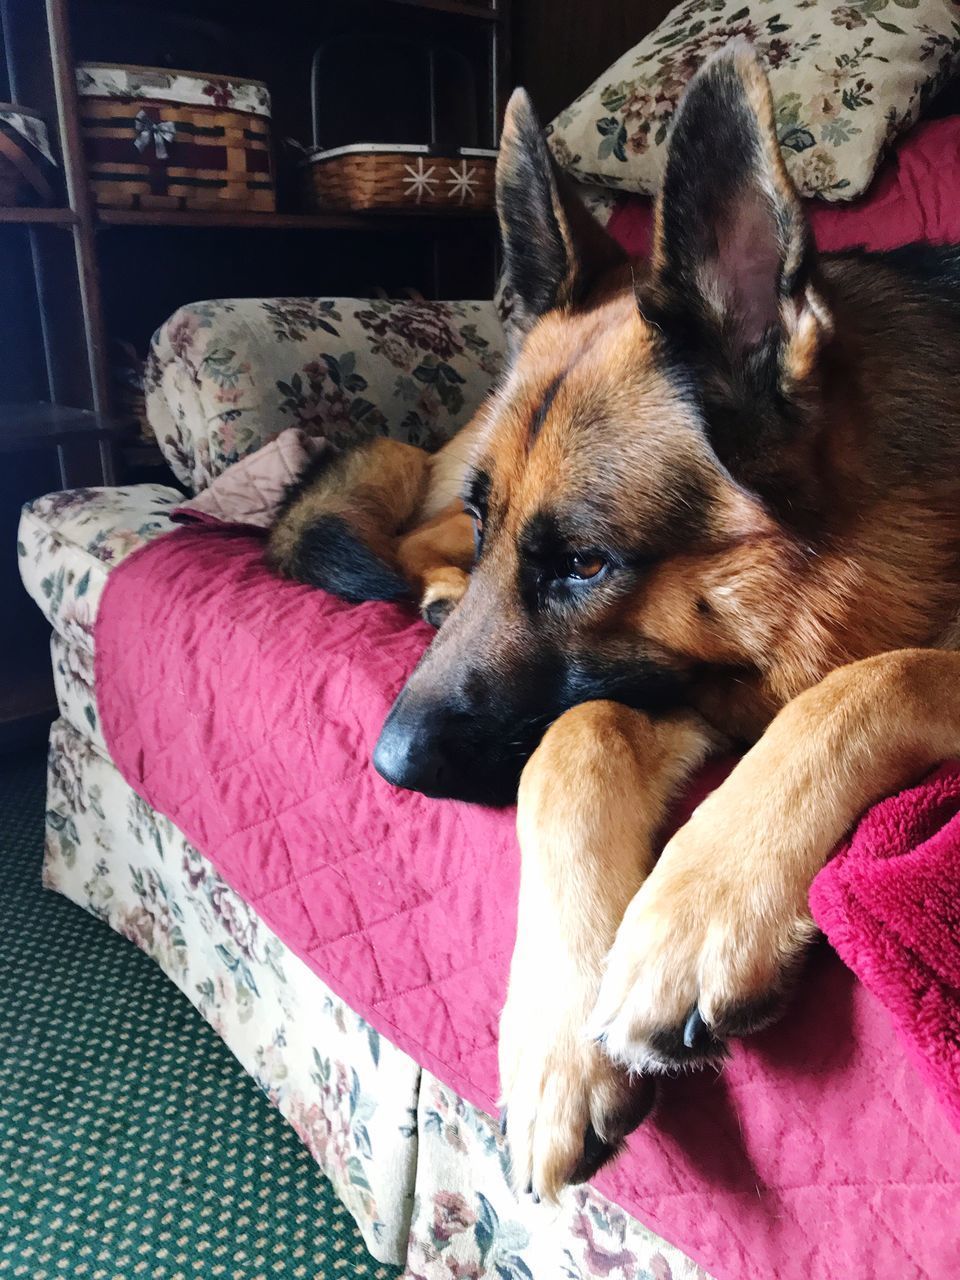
[{"left": 653, "top": 41, "right": 831, "bottom": 389}]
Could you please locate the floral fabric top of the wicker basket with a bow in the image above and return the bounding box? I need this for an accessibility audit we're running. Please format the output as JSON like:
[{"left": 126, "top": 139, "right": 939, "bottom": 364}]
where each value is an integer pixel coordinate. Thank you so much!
[{"left": 77, "top": 63, "right": 270, "bottom": 119}]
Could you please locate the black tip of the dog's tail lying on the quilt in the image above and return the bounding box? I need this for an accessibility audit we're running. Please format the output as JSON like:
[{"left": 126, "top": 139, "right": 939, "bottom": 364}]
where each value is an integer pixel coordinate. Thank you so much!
[{"left": 291, "top": 516, "right": 410, "bottom": 604}]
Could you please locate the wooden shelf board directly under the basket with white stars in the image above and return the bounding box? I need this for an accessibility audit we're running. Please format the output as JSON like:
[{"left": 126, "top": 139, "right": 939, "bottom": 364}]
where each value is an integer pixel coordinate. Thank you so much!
[{"left": 97, "top": 207, "right": 493, "bottom": 232}]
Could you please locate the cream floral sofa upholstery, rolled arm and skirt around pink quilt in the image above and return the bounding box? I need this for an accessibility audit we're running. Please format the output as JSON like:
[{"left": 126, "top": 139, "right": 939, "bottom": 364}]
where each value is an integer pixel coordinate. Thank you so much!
[{"left": 18, "top": 282, "right": 704, "bottom": 1280}]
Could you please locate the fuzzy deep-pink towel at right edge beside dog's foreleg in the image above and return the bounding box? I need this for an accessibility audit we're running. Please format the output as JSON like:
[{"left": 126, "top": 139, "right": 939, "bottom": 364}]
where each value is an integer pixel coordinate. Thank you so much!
[{"left": 810, "top": 764, "right": 960, "bottom": 1130}]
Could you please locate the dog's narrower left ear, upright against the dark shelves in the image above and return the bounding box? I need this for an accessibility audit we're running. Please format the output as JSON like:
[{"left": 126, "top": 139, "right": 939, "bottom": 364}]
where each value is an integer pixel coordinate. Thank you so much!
[{"left": 497, "top": 88, "right": 627, "bottom": 330}]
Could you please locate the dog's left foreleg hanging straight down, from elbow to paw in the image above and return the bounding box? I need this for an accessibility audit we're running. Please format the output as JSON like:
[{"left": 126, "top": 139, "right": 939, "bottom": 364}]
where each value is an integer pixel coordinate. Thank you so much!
[{"left": 499, "top": 701, "right": 710, "bottom": 1198}]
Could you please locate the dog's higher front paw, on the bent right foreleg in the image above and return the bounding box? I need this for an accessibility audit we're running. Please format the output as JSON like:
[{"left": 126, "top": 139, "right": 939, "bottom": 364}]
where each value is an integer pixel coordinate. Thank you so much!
[{"left": 588, "top": 788, "right": 814, "bottom": 1071}]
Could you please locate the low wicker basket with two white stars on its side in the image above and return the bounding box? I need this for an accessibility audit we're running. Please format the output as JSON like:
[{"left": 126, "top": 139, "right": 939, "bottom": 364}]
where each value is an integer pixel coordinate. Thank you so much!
[{"left": 302, "top": 142, "right": 497, "bottom": 214}]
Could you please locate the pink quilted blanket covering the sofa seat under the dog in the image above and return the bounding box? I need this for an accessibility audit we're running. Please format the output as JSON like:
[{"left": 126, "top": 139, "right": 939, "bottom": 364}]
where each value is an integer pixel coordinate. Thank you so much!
[{"left": 96, "top": 529, "right": 960, "bottom": 1280}]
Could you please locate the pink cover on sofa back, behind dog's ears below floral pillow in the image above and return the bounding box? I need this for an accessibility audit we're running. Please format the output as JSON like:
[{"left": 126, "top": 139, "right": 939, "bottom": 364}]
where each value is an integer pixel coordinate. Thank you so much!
[{"left": 607, "top": 115, "right": 960, "bottom": 256}]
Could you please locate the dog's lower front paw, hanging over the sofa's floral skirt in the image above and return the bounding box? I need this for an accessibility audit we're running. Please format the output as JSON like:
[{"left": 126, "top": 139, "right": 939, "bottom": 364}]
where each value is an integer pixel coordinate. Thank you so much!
[{"left": 499, "top": 963, "right": 654, "bottom": 1201}]
